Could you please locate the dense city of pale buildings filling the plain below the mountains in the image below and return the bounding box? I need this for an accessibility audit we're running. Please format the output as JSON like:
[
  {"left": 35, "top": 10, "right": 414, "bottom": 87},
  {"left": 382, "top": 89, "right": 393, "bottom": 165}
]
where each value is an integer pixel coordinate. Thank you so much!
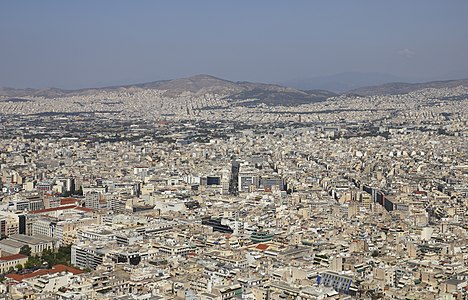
[{"left": 0, "top": 80, "right": 468, "bottom": 300}]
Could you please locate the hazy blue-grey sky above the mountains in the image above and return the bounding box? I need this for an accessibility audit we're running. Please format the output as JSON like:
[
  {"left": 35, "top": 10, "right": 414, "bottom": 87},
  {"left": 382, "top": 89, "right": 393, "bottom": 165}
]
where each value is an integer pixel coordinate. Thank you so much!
[{"left": 0, "top": 0, "right": 468, "bottom": 88}]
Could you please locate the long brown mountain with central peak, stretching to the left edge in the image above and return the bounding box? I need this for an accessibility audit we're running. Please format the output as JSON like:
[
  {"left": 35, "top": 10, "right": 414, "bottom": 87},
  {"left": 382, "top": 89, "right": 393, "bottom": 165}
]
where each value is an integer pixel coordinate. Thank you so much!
[{"left": 0, "top": 74, "right": 336, "bottom": 106}]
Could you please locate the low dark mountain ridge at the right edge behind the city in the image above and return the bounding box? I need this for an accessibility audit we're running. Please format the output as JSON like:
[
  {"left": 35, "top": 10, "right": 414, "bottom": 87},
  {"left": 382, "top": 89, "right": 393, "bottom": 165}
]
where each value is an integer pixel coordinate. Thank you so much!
[{"left": 346, "top": 79, "right": 468, "bottom": 96}]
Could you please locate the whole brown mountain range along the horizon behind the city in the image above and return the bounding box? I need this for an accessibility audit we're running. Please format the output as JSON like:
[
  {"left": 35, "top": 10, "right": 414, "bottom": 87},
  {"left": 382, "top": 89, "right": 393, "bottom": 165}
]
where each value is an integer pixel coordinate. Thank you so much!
[{"left": 0, "top": 75, "right": 468, "bottom": 106}]
